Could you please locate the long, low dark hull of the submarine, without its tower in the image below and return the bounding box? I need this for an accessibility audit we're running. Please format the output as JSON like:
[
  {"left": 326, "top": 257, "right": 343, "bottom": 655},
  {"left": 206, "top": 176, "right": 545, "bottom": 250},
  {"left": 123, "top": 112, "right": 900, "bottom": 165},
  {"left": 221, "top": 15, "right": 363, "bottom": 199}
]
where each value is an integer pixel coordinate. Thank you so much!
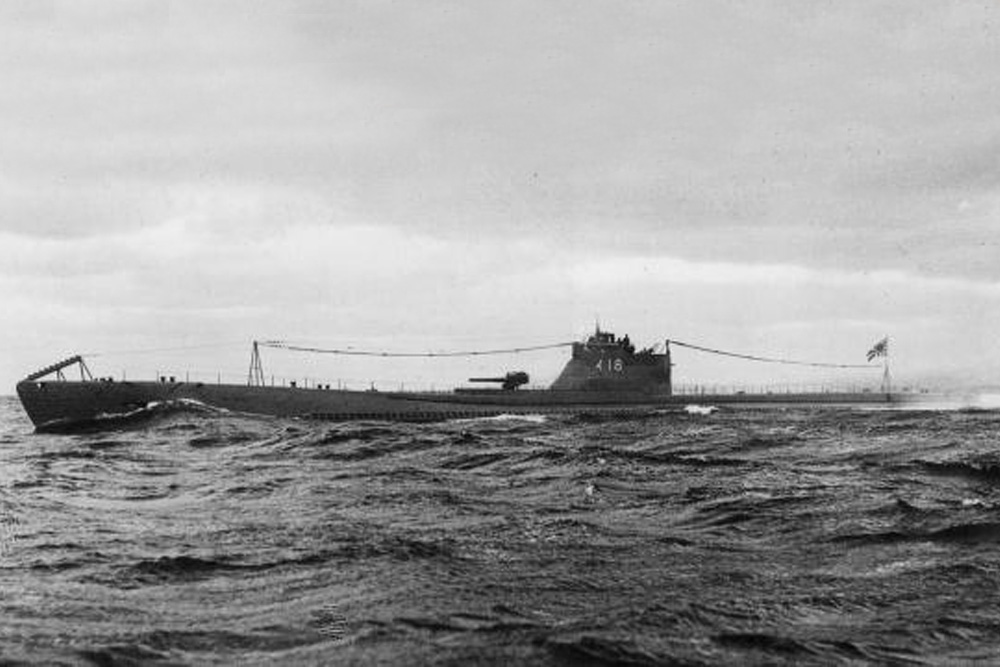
[{"left": 17, "top": 380, "right": 904, "bottom": 432}]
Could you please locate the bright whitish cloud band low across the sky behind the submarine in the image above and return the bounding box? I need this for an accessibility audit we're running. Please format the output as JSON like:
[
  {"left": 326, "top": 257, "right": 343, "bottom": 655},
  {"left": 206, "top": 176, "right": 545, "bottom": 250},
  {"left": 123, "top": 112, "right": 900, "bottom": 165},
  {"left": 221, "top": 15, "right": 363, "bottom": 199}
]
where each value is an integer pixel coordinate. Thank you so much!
[{"left": 0, "top": 219, "right": 1000, "bottom": 388}]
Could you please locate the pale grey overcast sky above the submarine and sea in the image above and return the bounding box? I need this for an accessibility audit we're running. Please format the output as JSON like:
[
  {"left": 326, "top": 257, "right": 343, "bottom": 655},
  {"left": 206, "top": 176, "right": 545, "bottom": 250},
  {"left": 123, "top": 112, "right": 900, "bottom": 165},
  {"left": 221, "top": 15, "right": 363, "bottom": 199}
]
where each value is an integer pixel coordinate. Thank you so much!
[{"left": 0, "top": 0, "right": 1000, "bottom": 393}]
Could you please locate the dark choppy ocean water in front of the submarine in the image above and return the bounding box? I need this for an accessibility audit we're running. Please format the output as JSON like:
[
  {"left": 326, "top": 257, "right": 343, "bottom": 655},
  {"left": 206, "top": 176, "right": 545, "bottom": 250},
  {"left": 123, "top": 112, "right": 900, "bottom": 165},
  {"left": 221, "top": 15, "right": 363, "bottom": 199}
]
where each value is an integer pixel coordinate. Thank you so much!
[{"left": 0, "top": 399, "right": 1000, "bottom": 665}]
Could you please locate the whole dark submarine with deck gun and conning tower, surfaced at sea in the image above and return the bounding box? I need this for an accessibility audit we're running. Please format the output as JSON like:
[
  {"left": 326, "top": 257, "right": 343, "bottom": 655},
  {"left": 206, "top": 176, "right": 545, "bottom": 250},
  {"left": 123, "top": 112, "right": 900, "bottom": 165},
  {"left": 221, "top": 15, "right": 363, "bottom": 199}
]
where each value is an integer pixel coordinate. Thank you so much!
[{"left": 17, "top": 327, "right": 906, "bottom": 432}]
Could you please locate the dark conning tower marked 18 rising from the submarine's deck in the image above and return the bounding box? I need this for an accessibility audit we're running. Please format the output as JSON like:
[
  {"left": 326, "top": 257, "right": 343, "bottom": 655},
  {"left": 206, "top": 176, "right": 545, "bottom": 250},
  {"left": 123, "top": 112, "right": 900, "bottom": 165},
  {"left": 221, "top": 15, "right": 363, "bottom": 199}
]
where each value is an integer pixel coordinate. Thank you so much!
[{"left": 551, "top": 328, "right": 671, "bottom": 395}]
